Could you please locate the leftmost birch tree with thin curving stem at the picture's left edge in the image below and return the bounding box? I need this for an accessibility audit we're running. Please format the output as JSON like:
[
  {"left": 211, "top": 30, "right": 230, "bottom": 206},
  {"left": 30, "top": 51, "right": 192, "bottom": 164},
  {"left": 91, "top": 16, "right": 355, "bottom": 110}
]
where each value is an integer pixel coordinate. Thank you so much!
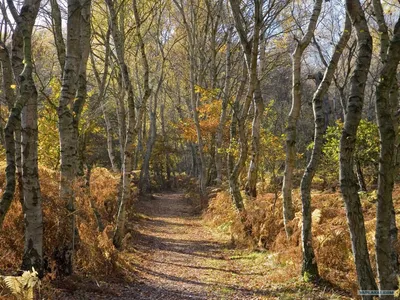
[{"left": 0, "top": 0, "right": 43, "bottom": 275}]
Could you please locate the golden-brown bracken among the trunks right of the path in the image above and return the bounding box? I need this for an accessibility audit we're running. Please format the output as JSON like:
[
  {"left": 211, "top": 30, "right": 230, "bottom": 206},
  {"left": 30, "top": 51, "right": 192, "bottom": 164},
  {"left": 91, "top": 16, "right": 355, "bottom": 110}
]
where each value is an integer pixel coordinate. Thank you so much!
[{"left": 204, "top": 186, "right": 400, "bottom": 297}]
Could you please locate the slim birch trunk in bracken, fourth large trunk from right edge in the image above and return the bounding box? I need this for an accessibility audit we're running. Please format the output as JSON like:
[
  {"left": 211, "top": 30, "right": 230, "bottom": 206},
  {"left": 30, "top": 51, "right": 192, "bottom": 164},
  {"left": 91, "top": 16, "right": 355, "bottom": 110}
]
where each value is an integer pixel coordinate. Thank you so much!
[{"left": 282, "top": 0, "right": 322, "bottom": 236}]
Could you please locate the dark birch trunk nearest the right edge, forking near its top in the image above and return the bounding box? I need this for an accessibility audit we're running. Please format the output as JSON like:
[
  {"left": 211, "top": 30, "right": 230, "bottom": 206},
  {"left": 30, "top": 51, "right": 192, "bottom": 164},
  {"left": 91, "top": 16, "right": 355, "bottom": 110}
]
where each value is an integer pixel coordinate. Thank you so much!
[{"left": 373, "top": 0, "right": 400, "bottom": 292}]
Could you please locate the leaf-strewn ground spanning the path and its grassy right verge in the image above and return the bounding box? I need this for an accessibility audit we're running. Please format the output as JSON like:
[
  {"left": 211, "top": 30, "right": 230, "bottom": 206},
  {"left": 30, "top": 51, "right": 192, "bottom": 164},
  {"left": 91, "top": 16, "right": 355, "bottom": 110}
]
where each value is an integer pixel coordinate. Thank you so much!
[{"left": 57, "top": 193, "right": 349, "bottom": 300}]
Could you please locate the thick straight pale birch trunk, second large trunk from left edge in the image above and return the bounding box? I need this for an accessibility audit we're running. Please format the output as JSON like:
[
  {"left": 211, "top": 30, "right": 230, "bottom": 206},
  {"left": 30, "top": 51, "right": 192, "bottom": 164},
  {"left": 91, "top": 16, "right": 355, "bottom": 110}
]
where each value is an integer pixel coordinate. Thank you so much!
[{"left": 55, "top": 0, "right": 91, "bottom": 275}]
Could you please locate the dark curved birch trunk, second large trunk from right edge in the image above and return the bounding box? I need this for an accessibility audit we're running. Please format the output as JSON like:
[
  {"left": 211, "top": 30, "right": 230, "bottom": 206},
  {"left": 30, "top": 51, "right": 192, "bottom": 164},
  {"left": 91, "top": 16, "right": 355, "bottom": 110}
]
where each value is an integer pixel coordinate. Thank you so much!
[{"left": 339, "top": 0, "right": 377, "bottom": 299}]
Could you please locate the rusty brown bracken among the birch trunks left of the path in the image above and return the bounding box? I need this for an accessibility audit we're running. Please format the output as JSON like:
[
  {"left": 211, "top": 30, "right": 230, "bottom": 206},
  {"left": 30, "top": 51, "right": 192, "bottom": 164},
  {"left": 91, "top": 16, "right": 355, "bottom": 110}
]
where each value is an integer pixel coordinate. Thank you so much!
[{"left": 0, "top": 167, "right": 131, "bottom": 295}]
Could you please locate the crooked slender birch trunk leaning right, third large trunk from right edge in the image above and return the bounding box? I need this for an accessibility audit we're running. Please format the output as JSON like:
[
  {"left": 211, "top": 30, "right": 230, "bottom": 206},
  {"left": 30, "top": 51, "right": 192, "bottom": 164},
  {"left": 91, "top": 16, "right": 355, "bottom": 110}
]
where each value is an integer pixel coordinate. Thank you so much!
[{"left": 300, "top": 14, "right": 351, "bottom": 280}]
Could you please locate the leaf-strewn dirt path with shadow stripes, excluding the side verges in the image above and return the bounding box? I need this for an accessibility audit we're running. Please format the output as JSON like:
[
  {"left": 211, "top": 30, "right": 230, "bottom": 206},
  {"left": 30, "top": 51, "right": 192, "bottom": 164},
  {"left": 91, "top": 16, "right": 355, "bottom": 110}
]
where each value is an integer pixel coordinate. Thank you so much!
[{"left": 121, "top": 193, "right": 273, "bottom": 299}]
